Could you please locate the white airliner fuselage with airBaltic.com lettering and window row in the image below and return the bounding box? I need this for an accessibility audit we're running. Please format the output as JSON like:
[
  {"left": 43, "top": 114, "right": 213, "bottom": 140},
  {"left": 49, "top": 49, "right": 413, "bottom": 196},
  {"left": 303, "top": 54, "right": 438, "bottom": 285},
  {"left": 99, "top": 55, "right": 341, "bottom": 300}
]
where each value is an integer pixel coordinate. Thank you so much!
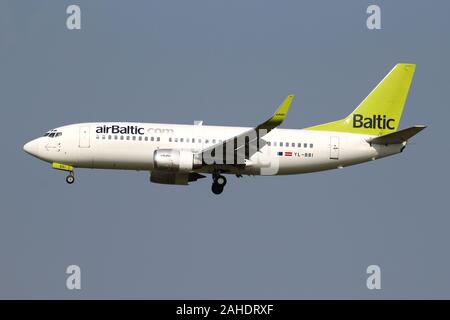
[{"left": 25, "top": 122, "right": 404, "bottom": 175}]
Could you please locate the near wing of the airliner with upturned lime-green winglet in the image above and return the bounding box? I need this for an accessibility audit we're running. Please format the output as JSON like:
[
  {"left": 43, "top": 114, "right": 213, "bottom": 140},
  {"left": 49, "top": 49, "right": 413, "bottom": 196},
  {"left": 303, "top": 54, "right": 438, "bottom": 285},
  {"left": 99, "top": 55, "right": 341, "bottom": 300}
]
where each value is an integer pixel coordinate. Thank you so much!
[{"left": 199, "top": 95, "right": 294, "bottom": 165}]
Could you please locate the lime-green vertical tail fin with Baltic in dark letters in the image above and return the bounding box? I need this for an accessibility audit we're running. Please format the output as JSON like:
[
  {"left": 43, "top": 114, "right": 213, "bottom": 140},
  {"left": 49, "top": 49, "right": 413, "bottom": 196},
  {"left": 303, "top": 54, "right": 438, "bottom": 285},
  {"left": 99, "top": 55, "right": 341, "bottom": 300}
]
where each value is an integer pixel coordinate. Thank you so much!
[{"left": 306, "top": 63, "right": 416, "bottom": 135}]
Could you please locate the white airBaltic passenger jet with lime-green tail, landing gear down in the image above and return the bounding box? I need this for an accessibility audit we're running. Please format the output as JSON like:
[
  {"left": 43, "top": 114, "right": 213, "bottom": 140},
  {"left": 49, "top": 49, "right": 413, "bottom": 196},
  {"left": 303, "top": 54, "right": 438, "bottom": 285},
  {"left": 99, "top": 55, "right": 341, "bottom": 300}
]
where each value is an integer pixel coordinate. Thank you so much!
[{"left": 23, "top": 63, "right": 426, "bottom": 194}]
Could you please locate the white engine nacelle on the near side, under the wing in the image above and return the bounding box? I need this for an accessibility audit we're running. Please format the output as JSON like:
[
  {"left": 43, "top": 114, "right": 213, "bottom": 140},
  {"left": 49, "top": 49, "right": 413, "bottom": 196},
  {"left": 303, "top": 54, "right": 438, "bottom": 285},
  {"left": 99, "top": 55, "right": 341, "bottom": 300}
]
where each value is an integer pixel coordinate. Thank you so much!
[{"left": 153, "top": 149, "right": 201, "bottom": 172}]
